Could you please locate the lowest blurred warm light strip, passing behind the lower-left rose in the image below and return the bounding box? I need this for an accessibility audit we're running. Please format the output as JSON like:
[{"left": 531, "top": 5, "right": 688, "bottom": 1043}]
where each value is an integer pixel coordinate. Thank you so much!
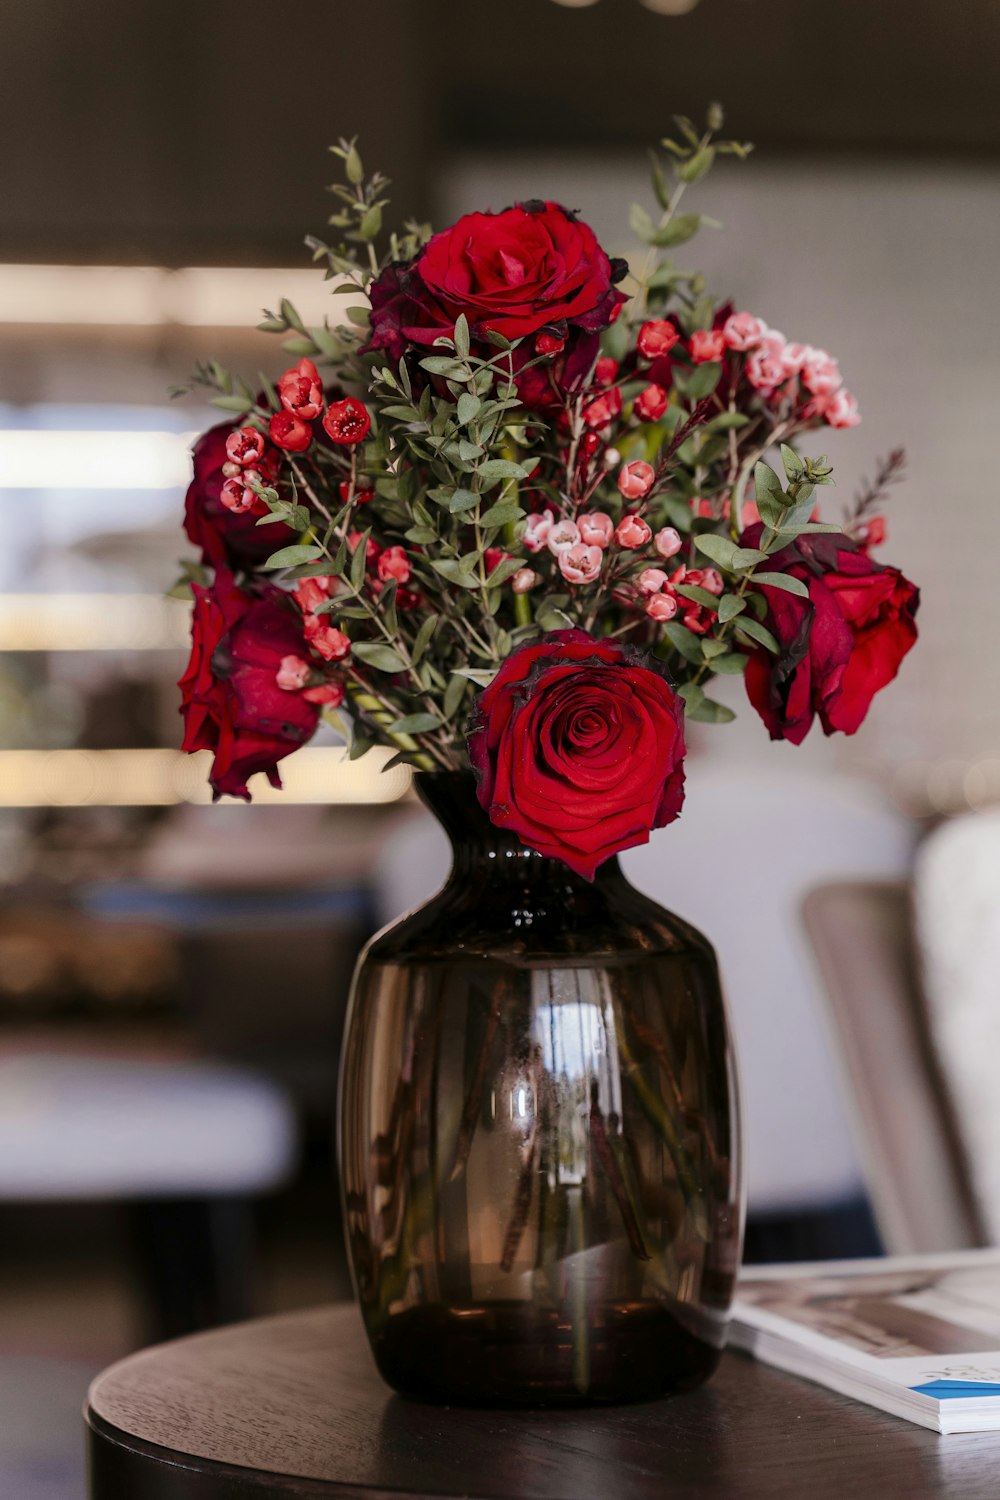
[{"left": 0, "top": 747, "right": 411, "bottom": 807}]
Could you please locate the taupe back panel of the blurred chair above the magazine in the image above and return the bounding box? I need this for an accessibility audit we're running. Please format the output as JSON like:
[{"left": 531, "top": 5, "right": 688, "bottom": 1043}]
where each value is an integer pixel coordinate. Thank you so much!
[{"left": 804, "top": 881, "right": 987, "bottom": 1254}]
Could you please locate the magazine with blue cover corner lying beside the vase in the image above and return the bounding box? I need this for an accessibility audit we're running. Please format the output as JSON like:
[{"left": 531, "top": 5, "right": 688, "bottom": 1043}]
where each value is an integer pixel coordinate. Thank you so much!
[{"left": 730, "top": 1250, "right": 1000, "bottom": 1433}]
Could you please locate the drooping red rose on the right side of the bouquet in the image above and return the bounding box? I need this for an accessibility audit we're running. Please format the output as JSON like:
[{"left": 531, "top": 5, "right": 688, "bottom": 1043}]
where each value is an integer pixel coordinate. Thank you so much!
[{"left": 741, "top": 525, "right": 919, "bottom": 744}]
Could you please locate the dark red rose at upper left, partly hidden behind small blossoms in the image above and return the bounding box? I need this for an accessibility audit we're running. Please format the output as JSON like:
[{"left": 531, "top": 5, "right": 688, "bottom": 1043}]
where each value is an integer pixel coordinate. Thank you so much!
[{"left": 184, "top": 422, "right": 297, "bottom": 567}]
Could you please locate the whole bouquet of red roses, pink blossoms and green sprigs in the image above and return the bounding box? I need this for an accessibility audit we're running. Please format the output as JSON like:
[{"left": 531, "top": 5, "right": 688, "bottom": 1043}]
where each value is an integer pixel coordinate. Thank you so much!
[{"left": 181, "top": 122, "right": 919, "bottom": 878}]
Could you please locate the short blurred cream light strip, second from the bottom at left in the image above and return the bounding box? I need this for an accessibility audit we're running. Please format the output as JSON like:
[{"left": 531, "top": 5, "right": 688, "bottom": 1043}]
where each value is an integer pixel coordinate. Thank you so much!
[{"left": 0, "top": 594, "right": 190, "bottom": 651}]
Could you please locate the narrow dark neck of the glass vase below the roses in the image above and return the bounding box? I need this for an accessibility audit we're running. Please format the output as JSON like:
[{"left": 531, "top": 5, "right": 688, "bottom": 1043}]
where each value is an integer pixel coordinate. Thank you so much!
[{"left": 417, "top": 771, "right": 625, "bottom": 899}]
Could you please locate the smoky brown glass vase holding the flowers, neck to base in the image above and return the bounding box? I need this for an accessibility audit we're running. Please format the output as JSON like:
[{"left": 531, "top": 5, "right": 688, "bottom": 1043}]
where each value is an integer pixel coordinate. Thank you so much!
[{"left": 340, "top": 773, "right": 742, "bottom": 1404}]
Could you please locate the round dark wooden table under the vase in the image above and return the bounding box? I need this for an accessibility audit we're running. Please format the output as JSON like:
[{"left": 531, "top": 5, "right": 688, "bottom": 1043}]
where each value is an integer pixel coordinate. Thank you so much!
[{"left": 87, "top": 1307, "right": 1000, "bottom": 1500}]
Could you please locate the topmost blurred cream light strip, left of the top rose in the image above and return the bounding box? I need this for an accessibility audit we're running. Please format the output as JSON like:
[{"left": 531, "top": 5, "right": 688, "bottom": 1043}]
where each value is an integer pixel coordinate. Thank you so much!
[{"left": 0, "top": 264, "right": 363, "bottom": 329}]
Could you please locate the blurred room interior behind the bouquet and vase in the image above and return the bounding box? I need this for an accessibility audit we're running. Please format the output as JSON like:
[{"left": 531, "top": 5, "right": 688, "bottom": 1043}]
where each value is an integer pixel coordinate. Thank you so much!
[{"left": 0, "top": 0, "right": 1000, "bottom": 1500}]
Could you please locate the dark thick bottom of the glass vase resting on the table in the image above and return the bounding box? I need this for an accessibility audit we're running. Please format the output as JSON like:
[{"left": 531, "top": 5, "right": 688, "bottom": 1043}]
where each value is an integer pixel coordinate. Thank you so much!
[{"left": 372, "top": 1302, "right": 721, "bottom": 1407}]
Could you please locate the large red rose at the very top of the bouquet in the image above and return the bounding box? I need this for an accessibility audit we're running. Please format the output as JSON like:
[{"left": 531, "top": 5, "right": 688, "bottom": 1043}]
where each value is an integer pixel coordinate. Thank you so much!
[{"left": 369, "top": 200, "right": 625, "bottom": 360}]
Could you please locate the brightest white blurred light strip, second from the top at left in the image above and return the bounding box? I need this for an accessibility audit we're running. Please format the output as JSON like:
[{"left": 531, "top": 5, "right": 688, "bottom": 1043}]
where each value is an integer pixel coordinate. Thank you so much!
[{"left": 0, "top": 428, "right": 196, "bottom": 491}]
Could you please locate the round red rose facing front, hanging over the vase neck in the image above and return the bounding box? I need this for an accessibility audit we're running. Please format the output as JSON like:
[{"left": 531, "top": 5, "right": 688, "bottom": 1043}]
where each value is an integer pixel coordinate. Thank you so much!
[{"left": 469, "top": 630, "right": 684, "bottom": 881}]
